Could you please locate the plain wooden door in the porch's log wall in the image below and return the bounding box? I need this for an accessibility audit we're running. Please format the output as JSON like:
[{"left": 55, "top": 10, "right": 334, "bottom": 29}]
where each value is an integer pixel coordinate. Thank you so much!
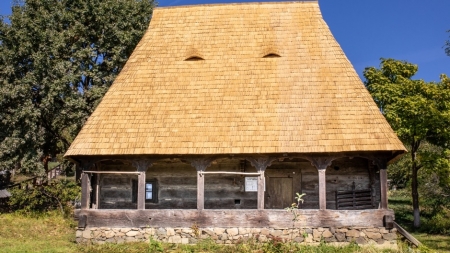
[{"left": 265, "top": 177, "right": 294, "bottom": 209}]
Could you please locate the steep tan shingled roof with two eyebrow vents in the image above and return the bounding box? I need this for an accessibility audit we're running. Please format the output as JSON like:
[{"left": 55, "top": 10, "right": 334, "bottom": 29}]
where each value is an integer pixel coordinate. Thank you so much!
[{"left": 66, "top": 1, "right": 405, "bottom": 156}]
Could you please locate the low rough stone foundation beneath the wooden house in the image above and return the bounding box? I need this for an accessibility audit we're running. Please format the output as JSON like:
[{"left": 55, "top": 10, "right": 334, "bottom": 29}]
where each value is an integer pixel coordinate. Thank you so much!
[{"left": 76, "top": 226, "right": 397, "bottom": 248}]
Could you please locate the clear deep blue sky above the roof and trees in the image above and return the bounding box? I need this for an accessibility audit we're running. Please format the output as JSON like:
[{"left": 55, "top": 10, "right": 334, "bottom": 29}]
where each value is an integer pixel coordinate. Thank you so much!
[{"left": 0, "top": 0, "right": 450, "bottom": 81}]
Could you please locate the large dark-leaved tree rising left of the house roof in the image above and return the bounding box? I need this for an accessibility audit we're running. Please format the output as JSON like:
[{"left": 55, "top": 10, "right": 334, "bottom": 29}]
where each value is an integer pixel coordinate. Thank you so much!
[{"left": 0, "top": 0, "right": 154, "bottom": 173}]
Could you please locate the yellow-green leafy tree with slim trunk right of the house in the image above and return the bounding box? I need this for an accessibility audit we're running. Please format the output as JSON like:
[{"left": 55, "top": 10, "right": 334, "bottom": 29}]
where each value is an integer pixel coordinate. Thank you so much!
[{"left": 364, "top": 59, "right": 450, "bottom": 227}]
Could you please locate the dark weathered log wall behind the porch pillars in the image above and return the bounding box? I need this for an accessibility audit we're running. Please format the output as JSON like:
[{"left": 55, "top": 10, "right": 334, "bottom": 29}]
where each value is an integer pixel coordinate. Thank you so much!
[{"left": 96, "top": 158, "right": 380, "bottom": 209}]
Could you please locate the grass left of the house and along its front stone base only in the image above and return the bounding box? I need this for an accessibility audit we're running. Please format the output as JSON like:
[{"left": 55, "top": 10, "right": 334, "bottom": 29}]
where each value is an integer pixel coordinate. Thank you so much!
[{"left": 0, "top": 212, "right": 403, "bottom": 253}]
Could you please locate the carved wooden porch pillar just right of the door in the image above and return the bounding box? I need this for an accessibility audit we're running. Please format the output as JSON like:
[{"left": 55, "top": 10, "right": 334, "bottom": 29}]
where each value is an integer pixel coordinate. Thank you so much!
[{"left": 306, "top": 156, "right": 338, "bottom": 210}]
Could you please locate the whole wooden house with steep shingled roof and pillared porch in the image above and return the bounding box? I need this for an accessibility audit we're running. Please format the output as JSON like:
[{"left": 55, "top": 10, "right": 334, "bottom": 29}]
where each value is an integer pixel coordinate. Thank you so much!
[{"left": 65, "top": 1, "right": 405, "bottom": 243}]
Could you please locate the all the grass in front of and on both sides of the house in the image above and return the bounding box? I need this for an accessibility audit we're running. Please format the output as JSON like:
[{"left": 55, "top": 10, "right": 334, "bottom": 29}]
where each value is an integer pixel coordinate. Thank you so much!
[{"left": 0, "top": 189, "right": 450, "bottom": 253}]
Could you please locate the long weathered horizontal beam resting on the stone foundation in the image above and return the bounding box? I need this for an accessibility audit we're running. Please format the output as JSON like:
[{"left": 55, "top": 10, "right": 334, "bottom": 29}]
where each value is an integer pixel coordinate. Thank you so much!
[{"left": 76, "top": 209, "right": 394, "bottom": 228}]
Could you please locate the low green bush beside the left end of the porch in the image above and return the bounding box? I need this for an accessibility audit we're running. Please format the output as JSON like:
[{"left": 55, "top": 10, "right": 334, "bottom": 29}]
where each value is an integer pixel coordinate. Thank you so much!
[{"left": 9, "top": 179, "right": 81, "bottom": 216}]
